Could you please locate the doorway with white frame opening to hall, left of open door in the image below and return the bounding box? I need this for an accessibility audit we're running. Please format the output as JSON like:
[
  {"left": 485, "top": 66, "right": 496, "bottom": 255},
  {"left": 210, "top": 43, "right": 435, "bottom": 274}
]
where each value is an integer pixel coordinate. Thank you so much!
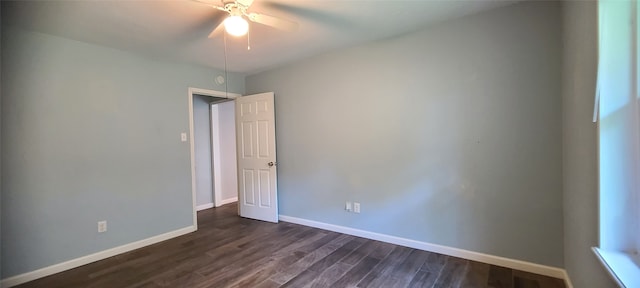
[{"left": 189, "top": 88, "right": 239, "bottom": 225}]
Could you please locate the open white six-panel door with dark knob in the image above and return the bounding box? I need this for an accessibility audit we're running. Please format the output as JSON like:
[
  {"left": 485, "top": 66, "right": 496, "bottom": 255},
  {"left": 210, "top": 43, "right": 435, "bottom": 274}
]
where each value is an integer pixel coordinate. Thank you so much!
[{"left": 236, "top": 92, "right": 278, "bottom": 223}]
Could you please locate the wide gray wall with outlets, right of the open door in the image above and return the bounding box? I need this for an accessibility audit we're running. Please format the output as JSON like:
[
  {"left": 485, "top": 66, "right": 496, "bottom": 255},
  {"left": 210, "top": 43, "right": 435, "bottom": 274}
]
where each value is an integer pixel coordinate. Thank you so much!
[{"left": 246, "top": 2, "right": 563, "bottom": 267}]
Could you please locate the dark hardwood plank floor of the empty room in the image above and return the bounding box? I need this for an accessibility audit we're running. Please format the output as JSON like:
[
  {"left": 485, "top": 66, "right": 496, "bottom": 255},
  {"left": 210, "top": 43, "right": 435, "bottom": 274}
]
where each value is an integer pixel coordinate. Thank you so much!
[{"left": 19, "top": 204, "right": 565, "bottom": 288}]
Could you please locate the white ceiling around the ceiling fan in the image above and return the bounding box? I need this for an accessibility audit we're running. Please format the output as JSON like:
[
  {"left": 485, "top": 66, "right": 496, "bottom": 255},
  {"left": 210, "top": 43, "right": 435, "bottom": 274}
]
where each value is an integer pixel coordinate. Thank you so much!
[{"left": 2, "top": 0, "right": 517, "bottom": 74}]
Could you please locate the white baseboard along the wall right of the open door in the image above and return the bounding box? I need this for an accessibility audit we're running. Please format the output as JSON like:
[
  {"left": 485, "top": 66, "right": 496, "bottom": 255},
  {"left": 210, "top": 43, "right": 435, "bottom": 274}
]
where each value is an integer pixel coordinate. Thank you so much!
[{"left": 279, "top": 215, "right": 570, "bottom": 280}]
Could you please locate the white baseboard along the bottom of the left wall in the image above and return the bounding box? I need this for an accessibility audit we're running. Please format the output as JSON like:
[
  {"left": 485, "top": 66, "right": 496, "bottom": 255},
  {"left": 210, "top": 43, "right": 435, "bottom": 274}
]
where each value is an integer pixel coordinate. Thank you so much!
[{"left": 0, "top": 226, "right": 197, "bottom": 288}]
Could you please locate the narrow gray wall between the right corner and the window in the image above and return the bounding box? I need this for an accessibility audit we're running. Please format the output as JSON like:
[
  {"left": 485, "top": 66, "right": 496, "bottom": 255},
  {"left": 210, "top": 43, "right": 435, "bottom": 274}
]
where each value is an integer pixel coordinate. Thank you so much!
[{"left": 562, "top": 1, "right": 615, "bottom": 288}]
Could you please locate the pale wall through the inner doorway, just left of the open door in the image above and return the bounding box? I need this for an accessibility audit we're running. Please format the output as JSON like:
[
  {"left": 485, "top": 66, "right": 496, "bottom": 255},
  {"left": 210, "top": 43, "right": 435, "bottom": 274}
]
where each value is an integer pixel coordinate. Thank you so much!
[{"left": 218, "top": 101, "right": 238, "bottom": 200}]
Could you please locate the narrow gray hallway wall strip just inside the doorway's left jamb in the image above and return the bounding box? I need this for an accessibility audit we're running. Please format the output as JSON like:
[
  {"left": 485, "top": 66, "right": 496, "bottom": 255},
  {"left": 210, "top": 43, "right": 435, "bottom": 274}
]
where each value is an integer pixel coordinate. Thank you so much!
[{"left": 193, "top": 95, "right": 214, "bottom": 206}]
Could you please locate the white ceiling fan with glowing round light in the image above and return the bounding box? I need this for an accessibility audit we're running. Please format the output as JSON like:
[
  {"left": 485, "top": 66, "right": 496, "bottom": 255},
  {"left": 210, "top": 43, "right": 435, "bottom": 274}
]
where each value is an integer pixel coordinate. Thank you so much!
[{"left": 193, "top": 0, "right": 298, "bottom": 38}]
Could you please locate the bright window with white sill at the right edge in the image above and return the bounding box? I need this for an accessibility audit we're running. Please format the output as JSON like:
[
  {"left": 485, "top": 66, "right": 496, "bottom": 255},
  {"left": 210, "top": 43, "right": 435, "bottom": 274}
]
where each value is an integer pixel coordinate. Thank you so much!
[{"left": 594, "top": 0, "right": 640, "bottom": 287}]
